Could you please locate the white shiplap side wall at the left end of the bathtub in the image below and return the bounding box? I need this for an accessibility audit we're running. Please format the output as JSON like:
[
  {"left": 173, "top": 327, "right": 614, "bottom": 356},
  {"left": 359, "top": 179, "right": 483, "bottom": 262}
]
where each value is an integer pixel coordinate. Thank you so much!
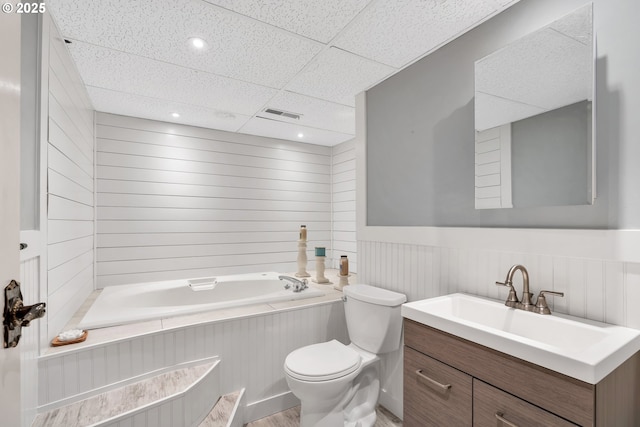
[{"left": 42, "top": 16, "right": 95, "bottom": 340}]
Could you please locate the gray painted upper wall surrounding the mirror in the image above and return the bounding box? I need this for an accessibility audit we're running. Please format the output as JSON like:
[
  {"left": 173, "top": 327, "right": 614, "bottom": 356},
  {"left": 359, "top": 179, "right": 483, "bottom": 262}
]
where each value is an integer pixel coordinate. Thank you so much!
[{"left": 367, "top": 0, "right": 640, "bottom": 228}]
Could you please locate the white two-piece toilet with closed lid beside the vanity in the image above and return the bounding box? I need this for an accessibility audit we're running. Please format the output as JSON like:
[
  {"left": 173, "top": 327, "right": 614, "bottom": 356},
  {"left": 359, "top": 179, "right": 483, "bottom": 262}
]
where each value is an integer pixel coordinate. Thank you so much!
[{"left": 284, "top": 285, "right": 407, "bottom": 427}]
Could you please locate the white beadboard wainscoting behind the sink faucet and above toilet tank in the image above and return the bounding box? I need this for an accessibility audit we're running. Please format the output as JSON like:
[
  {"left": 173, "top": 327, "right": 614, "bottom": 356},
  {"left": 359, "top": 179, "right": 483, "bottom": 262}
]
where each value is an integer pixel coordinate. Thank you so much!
[{"left": 358, "top": 241, "right": 640, "bottom": 329}]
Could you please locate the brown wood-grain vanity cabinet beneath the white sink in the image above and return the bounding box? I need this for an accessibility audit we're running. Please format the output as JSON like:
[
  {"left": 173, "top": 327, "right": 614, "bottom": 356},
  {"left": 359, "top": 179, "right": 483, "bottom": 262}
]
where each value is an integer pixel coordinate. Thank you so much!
[{"left": 404, "top": 319, "right": 640, "bottom": 427}]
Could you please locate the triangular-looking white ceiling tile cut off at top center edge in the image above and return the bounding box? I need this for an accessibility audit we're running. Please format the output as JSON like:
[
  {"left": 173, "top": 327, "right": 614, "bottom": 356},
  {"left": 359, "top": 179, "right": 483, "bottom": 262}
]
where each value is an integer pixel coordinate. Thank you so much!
[{"left": 205, "top": 0, "right": 370, "bottom": 43}]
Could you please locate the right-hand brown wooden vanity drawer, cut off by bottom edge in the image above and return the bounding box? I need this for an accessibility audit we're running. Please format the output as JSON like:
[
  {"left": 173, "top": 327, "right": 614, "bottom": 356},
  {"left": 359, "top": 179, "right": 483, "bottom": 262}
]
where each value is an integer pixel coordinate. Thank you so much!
[{"left": 473, "top": 379, "right": 576, "bottom": 427}]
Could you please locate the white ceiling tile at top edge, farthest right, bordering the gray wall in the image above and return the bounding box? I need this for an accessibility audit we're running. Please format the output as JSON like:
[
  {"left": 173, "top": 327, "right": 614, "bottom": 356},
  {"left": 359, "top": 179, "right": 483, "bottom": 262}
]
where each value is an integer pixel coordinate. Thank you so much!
[{"left": 335, "top": 0, "right": 513, "bottom": 68}]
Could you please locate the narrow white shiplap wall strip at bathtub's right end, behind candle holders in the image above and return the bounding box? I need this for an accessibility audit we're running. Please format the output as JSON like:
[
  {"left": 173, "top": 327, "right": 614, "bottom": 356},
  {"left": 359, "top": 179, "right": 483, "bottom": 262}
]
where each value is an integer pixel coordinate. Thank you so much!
[{"left": 331, "top": 139, "right": 358, "bottom": 273}]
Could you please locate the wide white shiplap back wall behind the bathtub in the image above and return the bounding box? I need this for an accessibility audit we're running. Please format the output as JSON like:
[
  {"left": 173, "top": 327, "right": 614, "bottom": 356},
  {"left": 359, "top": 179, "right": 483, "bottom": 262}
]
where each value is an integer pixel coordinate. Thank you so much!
[{"left": 96, "top": 113, "right": 332, "bottom": 288}]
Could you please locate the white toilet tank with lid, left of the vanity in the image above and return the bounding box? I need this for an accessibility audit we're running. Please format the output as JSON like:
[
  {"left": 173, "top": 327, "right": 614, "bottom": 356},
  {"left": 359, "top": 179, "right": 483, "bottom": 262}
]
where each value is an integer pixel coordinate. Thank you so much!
[{"left": 343, "top": 284, "right": 407, "bottom": 354}]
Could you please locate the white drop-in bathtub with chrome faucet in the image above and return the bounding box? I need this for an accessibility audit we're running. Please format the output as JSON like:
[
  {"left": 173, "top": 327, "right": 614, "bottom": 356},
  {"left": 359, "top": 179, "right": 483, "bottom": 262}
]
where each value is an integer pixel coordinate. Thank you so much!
[{"left": 78, "top": 272, "right": 324, "bottom": 329}]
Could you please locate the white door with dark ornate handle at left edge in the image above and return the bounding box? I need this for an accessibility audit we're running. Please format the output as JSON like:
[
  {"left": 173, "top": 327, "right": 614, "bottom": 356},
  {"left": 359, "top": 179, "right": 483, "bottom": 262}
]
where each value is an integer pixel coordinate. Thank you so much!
[{"left": 0, "top": 13, "right": 23, "bottom": 427}]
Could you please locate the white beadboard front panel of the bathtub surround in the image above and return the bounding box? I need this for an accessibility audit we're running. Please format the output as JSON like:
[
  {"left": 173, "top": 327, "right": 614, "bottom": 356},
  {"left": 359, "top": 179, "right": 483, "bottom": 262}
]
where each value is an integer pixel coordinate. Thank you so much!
[{"left": 38, "top": 301, "right": 349, "bottom": 418}]
